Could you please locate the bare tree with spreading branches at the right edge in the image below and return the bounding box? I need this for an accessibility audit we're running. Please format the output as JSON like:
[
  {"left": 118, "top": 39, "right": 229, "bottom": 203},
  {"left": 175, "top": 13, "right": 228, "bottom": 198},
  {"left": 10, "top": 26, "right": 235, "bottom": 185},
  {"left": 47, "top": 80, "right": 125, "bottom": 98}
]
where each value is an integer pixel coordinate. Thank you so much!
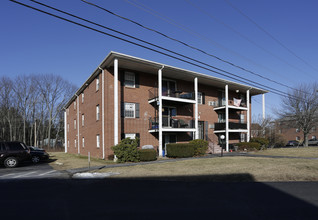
[{"left": 276, "top": 83, "right": 318, "bottom": 146}]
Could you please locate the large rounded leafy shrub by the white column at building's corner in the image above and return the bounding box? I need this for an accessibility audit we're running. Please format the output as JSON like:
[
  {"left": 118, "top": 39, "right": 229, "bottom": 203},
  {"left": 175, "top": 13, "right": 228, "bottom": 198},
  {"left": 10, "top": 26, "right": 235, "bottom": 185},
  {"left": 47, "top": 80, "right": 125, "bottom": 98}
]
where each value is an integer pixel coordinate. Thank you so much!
[{"left": 112, "top": 138, "right": 140, "bottom": 163}]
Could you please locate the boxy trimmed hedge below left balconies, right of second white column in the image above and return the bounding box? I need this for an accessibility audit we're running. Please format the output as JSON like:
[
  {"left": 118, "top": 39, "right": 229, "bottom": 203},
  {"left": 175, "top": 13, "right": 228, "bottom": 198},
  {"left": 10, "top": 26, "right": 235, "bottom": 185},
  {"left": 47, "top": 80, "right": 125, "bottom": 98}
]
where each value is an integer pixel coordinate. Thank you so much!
[{"left": 167, "top": 143, "right": 194, "bottom": 158}]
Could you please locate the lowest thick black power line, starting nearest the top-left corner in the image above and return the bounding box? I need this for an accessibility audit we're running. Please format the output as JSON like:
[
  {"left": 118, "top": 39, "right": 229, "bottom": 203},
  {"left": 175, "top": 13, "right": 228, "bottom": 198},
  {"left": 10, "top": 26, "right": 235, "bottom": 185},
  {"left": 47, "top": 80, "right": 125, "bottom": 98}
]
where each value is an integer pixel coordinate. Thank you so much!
[{"left": 10, "top": 0, "right": 299, "bottom": 99}]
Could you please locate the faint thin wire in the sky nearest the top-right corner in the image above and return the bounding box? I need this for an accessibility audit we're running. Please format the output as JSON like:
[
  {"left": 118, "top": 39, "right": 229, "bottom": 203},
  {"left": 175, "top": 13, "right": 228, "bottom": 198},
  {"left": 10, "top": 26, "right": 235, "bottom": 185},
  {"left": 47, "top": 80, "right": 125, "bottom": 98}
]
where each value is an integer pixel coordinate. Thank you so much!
[{"left": 224, "top": 0, "right": 318, "bottom": 72}]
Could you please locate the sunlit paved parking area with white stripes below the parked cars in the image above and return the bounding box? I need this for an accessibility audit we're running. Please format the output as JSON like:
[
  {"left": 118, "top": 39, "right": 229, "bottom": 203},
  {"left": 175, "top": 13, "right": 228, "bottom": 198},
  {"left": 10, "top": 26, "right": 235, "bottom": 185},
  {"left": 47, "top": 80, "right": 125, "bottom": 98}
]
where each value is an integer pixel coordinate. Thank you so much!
[{"left": 0, "top": 163, "right": 68, "bottom": 180}]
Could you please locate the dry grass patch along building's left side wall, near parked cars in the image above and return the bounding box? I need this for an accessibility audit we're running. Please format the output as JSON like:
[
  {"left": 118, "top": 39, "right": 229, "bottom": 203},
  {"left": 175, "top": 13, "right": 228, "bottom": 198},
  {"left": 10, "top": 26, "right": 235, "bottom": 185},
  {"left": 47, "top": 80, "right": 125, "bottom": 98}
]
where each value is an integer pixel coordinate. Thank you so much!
[{"left": 50, "top": 152, "right": 114, "bottom": 170}]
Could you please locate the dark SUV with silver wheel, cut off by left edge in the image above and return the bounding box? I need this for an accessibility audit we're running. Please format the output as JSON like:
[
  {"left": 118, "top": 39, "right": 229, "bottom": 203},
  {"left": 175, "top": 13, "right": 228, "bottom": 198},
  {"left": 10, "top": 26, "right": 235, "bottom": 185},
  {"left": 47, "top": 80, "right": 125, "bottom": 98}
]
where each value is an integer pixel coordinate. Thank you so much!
[{"left": 0, "top": 141, "right": 31, "bottom": 168}]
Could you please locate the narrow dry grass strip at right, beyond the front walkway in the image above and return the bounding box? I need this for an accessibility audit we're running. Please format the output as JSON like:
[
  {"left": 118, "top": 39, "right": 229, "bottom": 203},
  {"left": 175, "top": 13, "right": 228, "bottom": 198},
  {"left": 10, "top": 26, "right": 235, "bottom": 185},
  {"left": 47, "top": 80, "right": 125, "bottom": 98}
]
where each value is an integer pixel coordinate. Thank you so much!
[{"left": 254, "top": 147, "right": 318, "bottom": 158}]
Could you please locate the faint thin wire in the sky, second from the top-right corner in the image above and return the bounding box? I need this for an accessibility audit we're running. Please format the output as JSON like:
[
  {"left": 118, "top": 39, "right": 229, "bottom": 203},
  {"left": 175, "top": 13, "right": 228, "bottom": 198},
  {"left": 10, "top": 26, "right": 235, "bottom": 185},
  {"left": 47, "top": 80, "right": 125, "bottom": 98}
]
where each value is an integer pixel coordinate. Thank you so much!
[{"left": 184, "top": 0, "right": 311, "bottom": 76}]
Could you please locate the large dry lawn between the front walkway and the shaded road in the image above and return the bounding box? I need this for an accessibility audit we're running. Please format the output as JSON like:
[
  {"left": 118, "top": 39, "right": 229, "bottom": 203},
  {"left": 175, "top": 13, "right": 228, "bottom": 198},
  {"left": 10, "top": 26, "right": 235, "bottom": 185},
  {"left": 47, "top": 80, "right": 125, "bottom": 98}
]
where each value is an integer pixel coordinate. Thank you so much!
[{"left": 101, "top": 157, "right": 318, "bottom": 181}]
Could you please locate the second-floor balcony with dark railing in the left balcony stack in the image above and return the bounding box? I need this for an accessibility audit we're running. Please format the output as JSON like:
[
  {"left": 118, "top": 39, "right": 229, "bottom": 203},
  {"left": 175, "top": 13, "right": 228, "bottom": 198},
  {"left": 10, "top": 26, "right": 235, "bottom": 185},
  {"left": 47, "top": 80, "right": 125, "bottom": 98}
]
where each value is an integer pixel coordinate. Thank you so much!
[{"left": 149, "top": 116, "right": 194, "bottom": 130}]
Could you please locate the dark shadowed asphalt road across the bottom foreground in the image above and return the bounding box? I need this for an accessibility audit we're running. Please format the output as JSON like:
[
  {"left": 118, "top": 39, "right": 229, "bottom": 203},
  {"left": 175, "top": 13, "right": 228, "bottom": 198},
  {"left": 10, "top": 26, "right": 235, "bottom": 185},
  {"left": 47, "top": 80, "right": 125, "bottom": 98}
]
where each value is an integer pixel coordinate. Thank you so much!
[{"left": 0, "top": 174, "right": 318, "bottom": 220}]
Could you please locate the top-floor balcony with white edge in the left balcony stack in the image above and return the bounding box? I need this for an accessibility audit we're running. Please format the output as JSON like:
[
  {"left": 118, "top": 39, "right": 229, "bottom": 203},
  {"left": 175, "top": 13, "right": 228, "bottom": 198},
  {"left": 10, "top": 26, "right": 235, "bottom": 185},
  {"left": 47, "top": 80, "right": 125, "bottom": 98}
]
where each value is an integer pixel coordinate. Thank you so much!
[{"left": 148, "top": 87, "right": 195, "bottom": 103}]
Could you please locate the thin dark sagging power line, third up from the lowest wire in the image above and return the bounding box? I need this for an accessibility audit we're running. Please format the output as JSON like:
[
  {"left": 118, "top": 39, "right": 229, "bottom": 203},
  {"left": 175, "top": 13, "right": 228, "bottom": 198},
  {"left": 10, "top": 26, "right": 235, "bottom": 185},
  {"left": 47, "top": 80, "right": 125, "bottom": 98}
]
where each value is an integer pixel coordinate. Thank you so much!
[{"left": 81, "top": 0, "right": 308, "bottom": 94}]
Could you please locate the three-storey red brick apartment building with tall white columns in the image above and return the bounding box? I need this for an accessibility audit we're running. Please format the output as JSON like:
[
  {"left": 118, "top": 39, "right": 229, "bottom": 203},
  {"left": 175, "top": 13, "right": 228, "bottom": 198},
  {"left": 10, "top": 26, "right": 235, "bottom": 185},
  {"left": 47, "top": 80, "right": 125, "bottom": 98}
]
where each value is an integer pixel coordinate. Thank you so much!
[{"left": 65, "top": 52, "right": 267, "bottom": 159}]
